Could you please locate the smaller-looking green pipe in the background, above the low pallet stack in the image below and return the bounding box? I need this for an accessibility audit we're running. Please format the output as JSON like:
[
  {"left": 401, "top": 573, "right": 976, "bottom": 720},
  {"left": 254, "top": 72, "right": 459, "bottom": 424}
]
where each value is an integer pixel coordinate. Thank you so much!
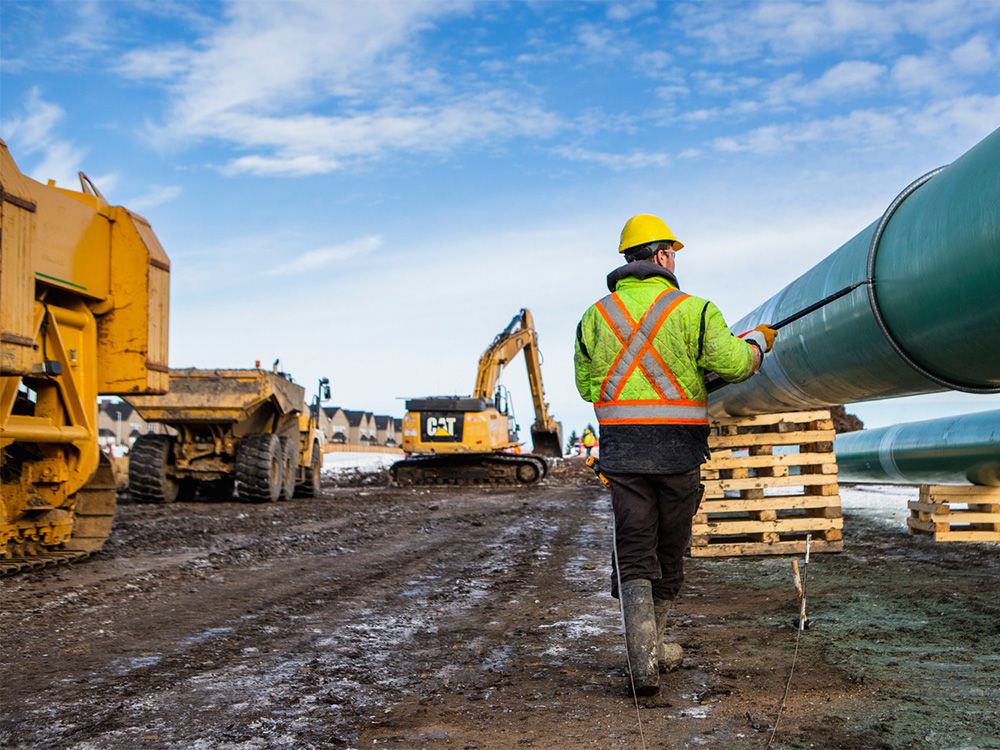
[{"left": 834, "top": 409, "right": 1000, "bottom": 487}]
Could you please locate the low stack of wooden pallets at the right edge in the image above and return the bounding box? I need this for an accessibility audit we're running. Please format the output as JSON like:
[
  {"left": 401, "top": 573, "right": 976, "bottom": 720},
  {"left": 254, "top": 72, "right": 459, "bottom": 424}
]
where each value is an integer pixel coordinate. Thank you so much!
[{"left": 906, "top": 484, "right": 1000, "bottom": 542}]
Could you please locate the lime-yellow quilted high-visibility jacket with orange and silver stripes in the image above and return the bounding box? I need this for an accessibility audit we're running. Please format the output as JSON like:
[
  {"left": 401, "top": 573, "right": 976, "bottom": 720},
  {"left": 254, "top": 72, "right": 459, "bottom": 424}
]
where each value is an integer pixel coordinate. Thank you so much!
[{"left": 574, "top": 263, "right": 761, "bottom": 435}]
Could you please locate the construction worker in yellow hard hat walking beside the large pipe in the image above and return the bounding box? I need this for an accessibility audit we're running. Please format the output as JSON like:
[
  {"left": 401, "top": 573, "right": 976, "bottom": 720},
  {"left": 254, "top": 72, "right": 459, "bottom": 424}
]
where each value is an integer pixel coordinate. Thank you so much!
[{"left": 574, "top": 214, "right": 777, "bottom": 695}]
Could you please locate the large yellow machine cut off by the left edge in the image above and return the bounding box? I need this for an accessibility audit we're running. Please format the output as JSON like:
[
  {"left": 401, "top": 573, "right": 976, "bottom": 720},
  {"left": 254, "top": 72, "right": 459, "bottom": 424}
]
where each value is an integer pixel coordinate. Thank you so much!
[{"left": 0, "top": 141, "right": 170, "bottom": 573}]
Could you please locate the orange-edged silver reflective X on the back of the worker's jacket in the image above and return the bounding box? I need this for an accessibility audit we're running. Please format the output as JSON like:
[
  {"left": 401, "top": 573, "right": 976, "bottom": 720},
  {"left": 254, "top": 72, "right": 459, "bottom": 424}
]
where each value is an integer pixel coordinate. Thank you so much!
[{"left": 597, "top": 289, "right": 688, "bottom": 401}]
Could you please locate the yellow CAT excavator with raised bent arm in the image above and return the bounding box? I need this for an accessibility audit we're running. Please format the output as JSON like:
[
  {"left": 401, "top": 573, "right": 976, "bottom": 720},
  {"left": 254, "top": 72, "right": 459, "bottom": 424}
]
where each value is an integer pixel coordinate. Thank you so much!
[{"left": 390, "top": 310, "right": 562, "bottom": 485}]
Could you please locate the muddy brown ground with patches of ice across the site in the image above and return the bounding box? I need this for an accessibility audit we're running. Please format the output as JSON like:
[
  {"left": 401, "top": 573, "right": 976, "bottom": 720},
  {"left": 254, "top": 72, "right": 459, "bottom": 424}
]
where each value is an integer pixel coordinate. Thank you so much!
[{"left": 0, "top": 468, "right": 1000, "bottom": 750}]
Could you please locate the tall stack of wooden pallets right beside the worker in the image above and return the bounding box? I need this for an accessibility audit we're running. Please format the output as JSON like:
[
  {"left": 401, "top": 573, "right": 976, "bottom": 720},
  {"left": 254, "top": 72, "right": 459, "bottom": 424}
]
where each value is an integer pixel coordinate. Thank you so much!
[{"left": 691, "top": 410, "right": 844, "bottom": 557}]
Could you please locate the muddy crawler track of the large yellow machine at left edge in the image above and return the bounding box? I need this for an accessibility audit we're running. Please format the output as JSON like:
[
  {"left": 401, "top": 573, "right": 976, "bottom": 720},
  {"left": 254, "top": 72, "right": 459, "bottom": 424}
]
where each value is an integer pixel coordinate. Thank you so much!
[{"left": 0, "top": 456, "right": 117, "bottom": 577}]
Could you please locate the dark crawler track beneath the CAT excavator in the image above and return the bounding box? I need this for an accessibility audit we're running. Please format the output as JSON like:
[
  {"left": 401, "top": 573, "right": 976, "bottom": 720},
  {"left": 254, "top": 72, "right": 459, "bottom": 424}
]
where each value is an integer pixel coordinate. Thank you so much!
[{"left": 389, "top": 453, "right": 548, "bottom": 487}]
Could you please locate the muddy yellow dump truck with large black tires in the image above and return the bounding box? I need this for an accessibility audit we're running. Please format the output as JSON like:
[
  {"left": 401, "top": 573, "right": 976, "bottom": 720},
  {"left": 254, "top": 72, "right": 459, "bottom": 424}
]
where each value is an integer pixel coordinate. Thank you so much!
[{"left": 127, "top": 368, "right": 329, "bottom": 503}]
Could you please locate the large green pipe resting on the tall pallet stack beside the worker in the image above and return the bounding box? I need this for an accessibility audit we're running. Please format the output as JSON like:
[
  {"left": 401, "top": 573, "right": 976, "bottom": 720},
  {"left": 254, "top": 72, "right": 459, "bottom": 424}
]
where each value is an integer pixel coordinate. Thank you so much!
[{"left": 709, "top": 123, "right": 1000, "bottom": 416}]
